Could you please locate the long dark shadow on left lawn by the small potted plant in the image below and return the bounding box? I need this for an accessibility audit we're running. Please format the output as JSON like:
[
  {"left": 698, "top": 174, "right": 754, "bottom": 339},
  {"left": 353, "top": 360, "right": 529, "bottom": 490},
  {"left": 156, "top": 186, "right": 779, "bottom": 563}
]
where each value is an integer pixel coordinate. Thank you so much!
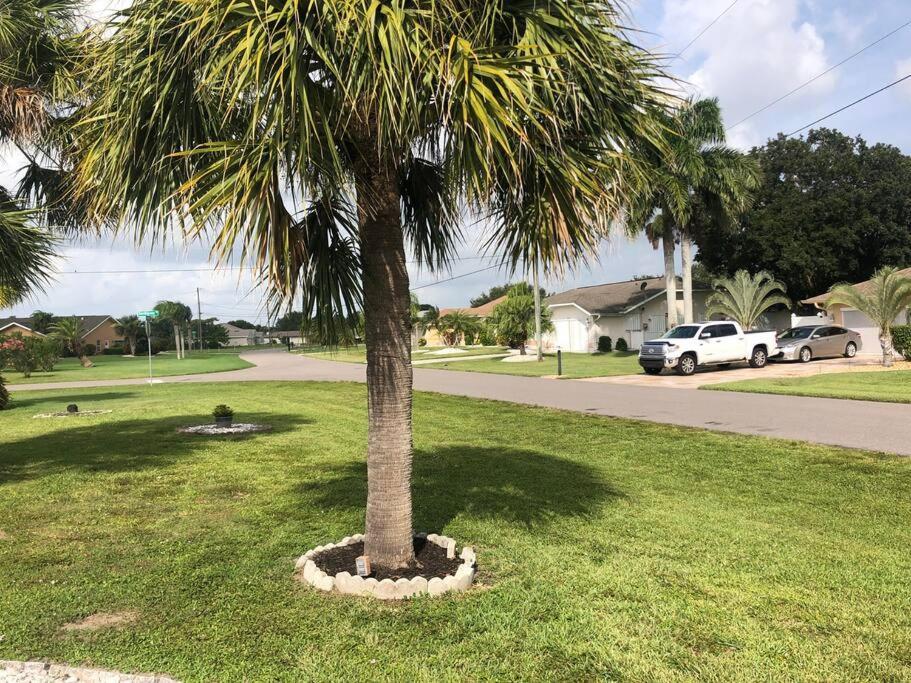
[{"left": 0, "top": 412, "right": 311, "bottom": 485}]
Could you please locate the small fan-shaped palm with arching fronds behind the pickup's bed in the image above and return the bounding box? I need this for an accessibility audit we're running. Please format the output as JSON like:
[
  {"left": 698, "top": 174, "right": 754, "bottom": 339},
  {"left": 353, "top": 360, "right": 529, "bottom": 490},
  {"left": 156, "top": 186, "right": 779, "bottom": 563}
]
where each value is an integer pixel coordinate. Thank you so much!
[{"left": 705, "top": 270, "right": 791, "bottom": 330}]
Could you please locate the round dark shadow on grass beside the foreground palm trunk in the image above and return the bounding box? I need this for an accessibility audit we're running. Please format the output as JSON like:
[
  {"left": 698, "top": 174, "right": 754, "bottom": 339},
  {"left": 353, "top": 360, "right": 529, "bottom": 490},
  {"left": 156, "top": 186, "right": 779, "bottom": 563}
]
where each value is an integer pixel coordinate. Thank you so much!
[{"left": 300, "top": 444, "right": 624, "bottom": 531}]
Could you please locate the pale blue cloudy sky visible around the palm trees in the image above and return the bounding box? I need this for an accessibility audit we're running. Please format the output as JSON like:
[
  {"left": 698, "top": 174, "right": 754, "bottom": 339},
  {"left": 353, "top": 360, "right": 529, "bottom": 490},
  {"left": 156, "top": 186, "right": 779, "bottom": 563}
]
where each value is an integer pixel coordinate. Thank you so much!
[{"left": 0, "top": 0, "right": 911, "bottom": 322}]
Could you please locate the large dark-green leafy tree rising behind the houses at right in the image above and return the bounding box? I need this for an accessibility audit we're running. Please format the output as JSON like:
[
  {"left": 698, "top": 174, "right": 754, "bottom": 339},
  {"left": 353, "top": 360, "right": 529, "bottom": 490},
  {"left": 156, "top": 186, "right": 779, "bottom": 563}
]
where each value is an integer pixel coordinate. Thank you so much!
[{"left": 696, "top": 128, "right": 911, "bottom": 301}]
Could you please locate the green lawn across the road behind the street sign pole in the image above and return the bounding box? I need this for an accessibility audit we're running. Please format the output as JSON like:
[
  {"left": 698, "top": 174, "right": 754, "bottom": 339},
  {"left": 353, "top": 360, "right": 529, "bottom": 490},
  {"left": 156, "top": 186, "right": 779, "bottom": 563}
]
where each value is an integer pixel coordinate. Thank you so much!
[{"left": 3, "top": 350, "right": 251, "bottom": 385}]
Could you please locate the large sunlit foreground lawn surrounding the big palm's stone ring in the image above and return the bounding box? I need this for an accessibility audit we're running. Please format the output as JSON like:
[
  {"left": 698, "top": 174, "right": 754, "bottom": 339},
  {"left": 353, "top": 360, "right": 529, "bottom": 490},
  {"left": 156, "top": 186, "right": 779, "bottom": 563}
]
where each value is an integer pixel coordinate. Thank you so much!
[{"left": 0, "top": 383, "right": 911, "bottom": 681}]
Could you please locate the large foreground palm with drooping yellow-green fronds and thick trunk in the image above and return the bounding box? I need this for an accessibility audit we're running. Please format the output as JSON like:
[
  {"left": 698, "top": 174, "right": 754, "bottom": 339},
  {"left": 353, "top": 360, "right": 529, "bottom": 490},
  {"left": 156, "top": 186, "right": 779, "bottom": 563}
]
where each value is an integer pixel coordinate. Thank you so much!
[{"left": 76, "top": 0, "right": 664, "bottom": 567}]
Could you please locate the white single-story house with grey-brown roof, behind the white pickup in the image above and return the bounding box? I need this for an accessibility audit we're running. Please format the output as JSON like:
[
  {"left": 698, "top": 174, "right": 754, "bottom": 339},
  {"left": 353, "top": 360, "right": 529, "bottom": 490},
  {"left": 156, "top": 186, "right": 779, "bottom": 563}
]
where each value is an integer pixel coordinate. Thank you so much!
[{"left": 544, "top": 276, "right": 711, "bottom": 353}]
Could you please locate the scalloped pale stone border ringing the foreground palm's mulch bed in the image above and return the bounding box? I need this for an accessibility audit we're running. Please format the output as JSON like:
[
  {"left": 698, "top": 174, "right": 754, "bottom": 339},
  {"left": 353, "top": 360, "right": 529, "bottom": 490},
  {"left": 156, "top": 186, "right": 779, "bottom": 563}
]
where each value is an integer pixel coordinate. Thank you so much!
[{"left": 295, "top": 534, "right": 477, "bottom": 600}]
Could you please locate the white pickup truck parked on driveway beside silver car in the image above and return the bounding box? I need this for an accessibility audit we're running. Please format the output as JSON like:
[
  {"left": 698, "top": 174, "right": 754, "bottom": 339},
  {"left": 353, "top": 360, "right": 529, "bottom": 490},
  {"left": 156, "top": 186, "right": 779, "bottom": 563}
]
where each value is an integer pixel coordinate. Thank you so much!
[{"left": 639, "top": 321, "right": 778, "bottom": 375}]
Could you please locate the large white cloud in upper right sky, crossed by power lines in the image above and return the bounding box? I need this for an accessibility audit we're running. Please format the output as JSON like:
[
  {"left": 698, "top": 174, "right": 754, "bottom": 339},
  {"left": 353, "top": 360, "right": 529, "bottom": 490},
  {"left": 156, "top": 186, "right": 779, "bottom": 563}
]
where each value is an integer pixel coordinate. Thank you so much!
[{"left": 660, "top": 0, "right": 837, "bottom": 147}]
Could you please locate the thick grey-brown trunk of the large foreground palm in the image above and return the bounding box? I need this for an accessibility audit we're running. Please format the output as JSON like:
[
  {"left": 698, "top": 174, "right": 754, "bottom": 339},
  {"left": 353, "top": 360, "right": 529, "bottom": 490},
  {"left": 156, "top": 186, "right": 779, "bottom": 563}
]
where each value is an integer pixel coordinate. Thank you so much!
[{"left": 356, "top": 158, "right": 414, "bottom": 569}]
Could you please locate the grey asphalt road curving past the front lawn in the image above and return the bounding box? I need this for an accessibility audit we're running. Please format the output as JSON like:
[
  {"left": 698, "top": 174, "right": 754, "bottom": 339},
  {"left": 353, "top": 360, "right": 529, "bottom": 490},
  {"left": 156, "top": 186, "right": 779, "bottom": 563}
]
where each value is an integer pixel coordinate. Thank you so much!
[{"left": 9, "top": 351, "right": 911, "bottom": 456}]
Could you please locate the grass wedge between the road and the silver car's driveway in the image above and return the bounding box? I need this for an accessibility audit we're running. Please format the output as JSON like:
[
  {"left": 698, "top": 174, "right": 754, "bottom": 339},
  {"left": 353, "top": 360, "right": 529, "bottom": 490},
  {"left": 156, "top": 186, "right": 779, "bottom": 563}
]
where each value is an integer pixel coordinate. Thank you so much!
[{"left": 702, "top": 370, "right": 911, "bottom": 403}]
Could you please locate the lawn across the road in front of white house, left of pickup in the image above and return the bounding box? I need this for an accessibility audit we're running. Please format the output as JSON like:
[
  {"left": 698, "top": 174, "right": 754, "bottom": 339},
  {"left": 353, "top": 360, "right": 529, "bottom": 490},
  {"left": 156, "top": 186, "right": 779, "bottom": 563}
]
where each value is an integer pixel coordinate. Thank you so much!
[{"left": 433, "top": 351, "right": 642, "bottom": 379}]
